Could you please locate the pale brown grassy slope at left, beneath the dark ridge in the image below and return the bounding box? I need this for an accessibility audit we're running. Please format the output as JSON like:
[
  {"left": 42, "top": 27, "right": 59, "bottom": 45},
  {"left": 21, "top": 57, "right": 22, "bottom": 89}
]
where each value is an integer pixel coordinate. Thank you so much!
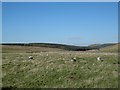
[{"left": 2, "top": 45, "right": 64, "bottom": 53}]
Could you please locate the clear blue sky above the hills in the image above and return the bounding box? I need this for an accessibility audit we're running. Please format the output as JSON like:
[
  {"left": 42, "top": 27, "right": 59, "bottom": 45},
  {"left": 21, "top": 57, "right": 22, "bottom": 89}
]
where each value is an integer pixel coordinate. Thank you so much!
[{"left": 2, "top": 2, "right": 118, "bottom": 45}]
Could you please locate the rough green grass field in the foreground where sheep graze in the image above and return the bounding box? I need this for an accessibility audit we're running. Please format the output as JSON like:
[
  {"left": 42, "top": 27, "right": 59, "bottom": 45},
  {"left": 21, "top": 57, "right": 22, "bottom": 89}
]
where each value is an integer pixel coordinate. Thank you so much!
[{"left": 2, "top": 44, "right": 118, "bottom": 88}]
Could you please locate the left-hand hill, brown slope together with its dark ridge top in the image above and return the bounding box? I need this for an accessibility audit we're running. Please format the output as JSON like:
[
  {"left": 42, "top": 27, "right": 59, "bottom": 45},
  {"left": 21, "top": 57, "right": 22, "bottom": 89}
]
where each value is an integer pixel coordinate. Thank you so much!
[{"left": 2, "top": 43, "right": 92, "bottom": 52}]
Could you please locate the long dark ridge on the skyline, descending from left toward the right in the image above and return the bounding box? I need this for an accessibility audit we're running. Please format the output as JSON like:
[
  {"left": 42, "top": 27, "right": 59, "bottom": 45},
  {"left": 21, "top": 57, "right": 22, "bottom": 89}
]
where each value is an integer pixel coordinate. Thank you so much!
[{"left": 2, "top": 43, "right": 95, "bottom": 51}]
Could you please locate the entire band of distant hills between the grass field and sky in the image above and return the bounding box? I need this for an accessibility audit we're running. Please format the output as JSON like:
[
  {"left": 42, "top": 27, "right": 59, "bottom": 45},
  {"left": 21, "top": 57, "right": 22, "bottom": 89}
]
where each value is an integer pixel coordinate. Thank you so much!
[{"left": 2, "top": 43, "right": 118, "bottom": 52}]
